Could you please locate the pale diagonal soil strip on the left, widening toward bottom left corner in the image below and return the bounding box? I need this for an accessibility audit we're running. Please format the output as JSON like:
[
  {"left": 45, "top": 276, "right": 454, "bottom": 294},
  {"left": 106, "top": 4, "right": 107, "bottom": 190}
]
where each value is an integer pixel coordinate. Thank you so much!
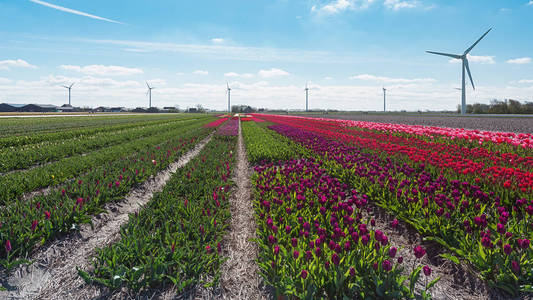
[{"left": 0, "top": 134, "right": 212, "bottom": 299}]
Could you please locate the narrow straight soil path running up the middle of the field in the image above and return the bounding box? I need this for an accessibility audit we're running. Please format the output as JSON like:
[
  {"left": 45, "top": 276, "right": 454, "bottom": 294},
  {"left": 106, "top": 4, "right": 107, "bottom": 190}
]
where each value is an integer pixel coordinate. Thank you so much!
[{"left": 219, "top": 122, "right": 267, "bottom": 299}]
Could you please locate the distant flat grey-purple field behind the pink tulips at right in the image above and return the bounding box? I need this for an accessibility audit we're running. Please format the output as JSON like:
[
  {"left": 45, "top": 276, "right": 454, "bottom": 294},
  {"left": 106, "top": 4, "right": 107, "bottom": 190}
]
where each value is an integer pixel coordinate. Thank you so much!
[{"left": 301, "top": 113, "right": 533, "bottom": 133}]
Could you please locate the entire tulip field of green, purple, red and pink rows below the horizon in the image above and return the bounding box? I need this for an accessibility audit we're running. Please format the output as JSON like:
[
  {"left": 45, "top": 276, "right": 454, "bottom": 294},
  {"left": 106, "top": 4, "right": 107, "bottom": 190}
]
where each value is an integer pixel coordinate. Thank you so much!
[{"left": 0, "top": 114, "right": 533, "bottom": 299}]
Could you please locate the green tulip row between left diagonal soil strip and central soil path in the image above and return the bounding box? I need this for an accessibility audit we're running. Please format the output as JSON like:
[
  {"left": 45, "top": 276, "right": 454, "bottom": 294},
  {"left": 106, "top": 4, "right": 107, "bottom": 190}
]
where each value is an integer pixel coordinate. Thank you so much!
[{"left": 79, "top": 135, "right": 236, "bottom": 292}]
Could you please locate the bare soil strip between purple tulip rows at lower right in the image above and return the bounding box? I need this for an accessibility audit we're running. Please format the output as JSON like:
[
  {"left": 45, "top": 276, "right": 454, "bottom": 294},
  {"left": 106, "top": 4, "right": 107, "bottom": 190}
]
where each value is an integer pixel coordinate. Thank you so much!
[{"left": 363, "top": 204, "right": 508, "bottom": 300}]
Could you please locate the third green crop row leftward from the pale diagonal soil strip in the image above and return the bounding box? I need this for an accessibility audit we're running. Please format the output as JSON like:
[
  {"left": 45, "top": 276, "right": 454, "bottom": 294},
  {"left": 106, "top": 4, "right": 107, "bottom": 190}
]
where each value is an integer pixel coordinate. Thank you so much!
[{"left": 0, "top": 119, "right": 208, "bottom": 172}]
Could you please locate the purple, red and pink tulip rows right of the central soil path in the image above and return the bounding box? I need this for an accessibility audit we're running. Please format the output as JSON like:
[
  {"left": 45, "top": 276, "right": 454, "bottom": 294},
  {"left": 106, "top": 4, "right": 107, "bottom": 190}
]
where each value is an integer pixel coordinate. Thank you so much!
[{"left": 247, "top": 115, "right": 533, "bottom": 298}]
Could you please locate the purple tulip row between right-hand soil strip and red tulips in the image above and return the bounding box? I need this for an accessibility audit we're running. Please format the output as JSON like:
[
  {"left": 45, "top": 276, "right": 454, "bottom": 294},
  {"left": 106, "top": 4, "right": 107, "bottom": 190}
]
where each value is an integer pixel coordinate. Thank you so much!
[{"left": 271, "top": 121, "right": 533, "bottom": 293}]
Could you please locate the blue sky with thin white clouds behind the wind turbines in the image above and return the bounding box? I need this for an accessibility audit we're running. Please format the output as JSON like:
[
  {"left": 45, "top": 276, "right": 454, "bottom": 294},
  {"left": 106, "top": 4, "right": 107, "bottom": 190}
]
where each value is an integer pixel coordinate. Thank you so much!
[{"left": 0, "top": 0, "right": 533, "bottom": 110}]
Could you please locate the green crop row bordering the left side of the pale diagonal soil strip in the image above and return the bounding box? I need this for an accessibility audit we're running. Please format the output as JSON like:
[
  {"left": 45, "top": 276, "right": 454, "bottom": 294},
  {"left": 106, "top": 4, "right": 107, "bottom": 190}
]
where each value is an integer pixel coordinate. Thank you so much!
[{"left": 0, "top": 124, "right": 212, "bottom": 267}]
